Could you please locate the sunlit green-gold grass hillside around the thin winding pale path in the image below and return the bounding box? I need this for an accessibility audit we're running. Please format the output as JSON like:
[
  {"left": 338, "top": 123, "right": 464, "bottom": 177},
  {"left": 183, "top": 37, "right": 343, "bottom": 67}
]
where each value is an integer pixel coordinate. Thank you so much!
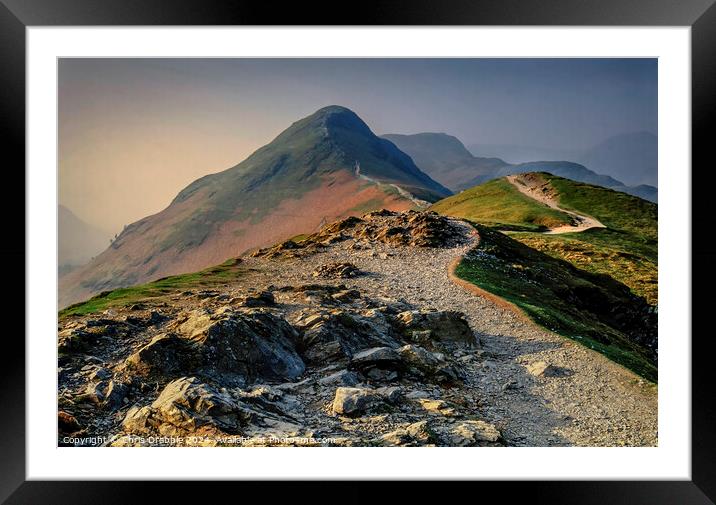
[{"left": 431, "top": 173, "right": 658, "bottom": 305}]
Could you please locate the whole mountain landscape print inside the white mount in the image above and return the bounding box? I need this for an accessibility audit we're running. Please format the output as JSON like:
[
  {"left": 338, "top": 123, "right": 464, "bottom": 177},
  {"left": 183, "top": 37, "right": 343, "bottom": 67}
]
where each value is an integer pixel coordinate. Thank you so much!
[{"left": 58, "top": 58, "right": 659, "bottom": 448}]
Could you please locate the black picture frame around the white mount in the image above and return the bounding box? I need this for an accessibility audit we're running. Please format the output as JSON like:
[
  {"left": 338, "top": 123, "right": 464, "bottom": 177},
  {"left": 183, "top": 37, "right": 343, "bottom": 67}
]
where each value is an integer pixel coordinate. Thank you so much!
[{"left": 0, "top": 0, "right": 716, "bottom": 505}]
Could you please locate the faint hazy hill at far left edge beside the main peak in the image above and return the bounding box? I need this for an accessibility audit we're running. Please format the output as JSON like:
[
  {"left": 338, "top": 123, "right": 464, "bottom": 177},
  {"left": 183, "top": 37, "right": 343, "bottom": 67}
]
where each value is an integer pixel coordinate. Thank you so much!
[{"left": 57, "top": 205, "right": 110, "bottom": 275}]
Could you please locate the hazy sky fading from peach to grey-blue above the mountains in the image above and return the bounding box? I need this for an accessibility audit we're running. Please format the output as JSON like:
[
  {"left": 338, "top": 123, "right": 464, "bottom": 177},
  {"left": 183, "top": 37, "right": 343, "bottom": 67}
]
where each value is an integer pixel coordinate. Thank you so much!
[{"left": 59, "top": 59, "right": 657, "bottom": 232}]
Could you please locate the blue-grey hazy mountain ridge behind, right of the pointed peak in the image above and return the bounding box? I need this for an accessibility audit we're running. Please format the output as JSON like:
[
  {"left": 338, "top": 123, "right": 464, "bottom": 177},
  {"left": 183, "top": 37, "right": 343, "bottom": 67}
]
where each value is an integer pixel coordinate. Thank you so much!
[{"left": 383, "top": 133, "right": 658, "bottom": 202}]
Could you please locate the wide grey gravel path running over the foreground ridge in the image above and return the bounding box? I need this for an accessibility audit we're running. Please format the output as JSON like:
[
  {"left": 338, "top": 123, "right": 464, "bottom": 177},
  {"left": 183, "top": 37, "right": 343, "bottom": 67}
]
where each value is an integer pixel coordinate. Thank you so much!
[{"left": 246, "top": 221, "right": 657, "bottom": 446}]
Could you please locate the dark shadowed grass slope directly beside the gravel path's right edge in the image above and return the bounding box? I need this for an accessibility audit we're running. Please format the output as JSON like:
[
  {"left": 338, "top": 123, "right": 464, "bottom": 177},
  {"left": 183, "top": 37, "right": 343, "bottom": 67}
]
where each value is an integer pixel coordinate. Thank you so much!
[{"left": 456, "top": 225, "right": 657, "bottom": 382}]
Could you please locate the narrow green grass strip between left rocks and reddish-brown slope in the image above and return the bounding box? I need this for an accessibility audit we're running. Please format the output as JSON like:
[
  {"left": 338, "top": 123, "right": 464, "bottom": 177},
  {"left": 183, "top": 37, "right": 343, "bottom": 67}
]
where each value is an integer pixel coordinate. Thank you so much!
[{"left": 59, "top": 259, "right": 246, "bottom": 319}]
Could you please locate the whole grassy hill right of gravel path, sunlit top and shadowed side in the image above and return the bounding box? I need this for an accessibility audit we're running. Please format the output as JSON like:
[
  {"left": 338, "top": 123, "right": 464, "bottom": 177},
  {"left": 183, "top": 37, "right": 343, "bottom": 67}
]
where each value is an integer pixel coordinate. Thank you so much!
[{"left": 431, "top": 173, "right": 658, "bottom": 380}]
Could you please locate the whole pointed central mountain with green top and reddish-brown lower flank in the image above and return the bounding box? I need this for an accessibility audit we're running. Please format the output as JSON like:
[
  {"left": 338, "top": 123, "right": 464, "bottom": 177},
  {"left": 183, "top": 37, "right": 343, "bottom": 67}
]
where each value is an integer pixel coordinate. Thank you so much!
[{"left": 60, "top": 106, "right": 450, "bottom": 306}]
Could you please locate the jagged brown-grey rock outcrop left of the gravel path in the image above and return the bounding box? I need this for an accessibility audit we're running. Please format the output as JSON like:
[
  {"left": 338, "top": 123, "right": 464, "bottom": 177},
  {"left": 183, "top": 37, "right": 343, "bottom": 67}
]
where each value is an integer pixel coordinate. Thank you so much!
[{"left": 58, "top": 211, "right": 501, "bottom": 446}]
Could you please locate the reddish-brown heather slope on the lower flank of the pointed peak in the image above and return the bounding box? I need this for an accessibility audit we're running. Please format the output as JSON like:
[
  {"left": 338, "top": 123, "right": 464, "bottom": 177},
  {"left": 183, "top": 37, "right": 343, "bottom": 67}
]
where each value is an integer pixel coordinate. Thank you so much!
[{"left": 60, "top": 171, "right": 414, "bottom": 306}]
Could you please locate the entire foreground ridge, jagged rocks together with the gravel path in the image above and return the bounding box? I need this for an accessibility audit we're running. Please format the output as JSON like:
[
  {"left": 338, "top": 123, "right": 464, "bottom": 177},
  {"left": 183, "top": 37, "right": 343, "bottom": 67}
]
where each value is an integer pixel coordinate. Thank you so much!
[{"left": 58, "top": 211, "right": 656, "bottom": 446}]
